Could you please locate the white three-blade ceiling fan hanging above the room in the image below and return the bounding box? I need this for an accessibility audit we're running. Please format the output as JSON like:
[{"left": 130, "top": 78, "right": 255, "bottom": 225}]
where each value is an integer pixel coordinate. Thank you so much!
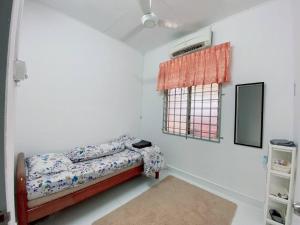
[{"left": 123, "top": 0, "right": 180, "bottom": 41}]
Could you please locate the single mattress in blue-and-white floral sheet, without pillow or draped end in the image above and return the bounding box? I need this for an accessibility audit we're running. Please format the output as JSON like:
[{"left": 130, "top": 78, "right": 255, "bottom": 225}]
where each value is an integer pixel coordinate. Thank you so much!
[{"left": 26, "top": 150, "right": 143, "bottom": 202}]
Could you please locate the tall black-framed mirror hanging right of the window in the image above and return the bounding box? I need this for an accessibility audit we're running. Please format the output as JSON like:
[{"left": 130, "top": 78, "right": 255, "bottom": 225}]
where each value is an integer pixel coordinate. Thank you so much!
[{"left": 234, "top": 82, "right": 264, "bottom": 148}]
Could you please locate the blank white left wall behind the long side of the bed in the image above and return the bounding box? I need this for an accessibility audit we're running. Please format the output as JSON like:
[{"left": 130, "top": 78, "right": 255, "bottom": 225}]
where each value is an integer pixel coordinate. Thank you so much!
[{"left": 16, "top": 0, "right": 143, "bottom": 155}]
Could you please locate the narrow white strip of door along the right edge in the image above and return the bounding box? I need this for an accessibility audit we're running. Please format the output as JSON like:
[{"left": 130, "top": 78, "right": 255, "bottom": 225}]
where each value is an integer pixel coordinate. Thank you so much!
[{"left": 291, "top": 0, "right": 300, "bottom": 222}]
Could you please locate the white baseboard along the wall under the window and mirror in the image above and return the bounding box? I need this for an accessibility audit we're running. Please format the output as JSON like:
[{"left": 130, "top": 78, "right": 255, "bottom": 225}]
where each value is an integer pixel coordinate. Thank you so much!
[{"left": 167, "top": 164, "right": 264, "bottom": 209}]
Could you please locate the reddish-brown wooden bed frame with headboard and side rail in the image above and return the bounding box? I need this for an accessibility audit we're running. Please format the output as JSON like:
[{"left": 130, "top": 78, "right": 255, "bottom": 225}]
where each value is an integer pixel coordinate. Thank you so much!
[{"left": 16, "top": 153, "right": 159, "bottom": 225}]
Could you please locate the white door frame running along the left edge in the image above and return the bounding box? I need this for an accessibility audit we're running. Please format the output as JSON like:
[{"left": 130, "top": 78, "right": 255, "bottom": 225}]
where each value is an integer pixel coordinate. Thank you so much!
[{"left": 4, "top": 0, "right": 24, "bottom": 225}]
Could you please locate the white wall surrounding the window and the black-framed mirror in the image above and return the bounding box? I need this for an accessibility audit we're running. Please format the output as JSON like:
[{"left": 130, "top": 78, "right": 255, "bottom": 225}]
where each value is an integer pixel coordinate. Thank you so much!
[{"left": 142, "top": 0, "right": 293, "bottom": 204}]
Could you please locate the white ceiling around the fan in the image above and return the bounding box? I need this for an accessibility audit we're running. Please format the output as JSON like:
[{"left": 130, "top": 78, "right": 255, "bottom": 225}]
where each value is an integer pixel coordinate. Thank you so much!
[{"left": 38, "top": 0, "right": 267, "bottom": 53}]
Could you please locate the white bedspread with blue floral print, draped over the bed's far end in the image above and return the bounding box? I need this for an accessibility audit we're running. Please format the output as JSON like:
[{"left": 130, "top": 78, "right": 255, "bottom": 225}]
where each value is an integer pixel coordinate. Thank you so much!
[{"left": 26, "top": 135, "right": 164, "bottom": 200}]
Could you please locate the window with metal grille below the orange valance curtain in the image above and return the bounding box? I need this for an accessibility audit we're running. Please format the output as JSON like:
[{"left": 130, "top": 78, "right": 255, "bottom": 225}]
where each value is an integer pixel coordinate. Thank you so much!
[{"left": 163, "top": 84, "right": 221, "bottom": 142}]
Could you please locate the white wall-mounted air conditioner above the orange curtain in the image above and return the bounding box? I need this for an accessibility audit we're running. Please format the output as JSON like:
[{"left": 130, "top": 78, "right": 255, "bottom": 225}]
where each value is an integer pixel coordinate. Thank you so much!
[{"left": 170, "top": 29, "right": 212, "bottom": 58}]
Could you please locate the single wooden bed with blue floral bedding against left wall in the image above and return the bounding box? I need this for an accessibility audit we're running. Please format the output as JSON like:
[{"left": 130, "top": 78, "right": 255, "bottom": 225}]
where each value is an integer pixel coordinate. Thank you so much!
[{"left": 16, "top": 135, "right": 163, "bottom": 225}]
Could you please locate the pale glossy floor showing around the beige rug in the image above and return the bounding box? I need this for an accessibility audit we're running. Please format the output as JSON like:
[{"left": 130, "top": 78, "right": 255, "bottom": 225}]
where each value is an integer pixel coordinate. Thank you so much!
[{"left": 34, "top": 171, "right": 263, "bottom": 225}]
